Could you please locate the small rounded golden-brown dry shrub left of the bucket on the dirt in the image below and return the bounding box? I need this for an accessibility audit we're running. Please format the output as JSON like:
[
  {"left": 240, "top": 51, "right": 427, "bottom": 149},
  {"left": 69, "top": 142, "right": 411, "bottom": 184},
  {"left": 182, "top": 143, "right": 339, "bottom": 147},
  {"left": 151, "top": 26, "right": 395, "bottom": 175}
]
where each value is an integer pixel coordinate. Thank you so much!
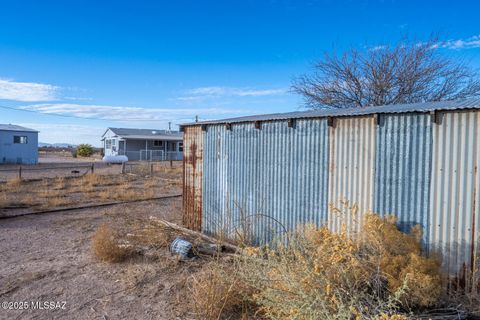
[{"left": 92, "top": 224, "right": 132, "bottom": 262}]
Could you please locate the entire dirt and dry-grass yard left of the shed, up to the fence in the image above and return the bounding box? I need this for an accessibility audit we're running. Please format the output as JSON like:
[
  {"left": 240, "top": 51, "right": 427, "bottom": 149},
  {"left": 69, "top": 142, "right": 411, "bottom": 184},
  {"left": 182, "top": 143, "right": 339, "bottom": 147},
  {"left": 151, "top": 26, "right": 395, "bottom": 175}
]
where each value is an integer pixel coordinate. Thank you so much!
[{"left": 0, "top": 158, "right": 208, "bottom": 319}]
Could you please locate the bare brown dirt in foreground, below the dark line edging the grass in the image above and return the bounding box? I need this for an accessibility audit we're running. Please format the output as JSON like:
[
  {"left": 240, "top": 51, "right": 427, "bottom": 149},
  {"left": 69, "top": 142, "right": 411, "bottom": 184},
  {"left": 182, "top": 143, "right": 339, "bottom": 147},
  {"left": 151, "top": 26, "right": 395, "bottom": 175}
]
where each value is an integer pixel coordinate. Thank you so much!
[{"left": 0, "top": 198, "right": 195, "bottom": 319}]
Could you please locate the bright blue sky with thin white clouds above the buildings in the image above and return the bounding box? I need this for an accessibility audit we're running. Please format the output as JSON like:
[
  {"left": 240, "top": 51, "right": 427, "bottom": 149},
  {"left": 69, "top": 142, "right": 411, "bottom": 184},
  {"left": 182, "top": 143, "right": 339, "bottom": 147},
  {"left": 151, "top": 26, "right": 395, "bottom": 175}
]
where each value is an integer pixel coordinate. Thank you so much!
[{"left": 0, "top": 0, "right": 480, "bottom": 145}]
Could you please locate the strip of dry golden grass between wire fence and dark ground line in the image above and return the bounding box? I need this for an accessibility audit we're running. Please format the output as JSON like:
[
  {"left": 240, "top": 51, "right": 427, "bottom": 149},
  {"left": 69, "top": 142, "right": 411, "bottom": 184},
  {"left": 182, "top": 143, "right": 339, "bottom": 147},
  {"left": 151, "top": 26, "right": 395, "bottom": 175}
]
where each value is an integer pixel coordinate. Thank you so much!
[{"left": 0, "top": 164, "right": 181, "bottom": 214}]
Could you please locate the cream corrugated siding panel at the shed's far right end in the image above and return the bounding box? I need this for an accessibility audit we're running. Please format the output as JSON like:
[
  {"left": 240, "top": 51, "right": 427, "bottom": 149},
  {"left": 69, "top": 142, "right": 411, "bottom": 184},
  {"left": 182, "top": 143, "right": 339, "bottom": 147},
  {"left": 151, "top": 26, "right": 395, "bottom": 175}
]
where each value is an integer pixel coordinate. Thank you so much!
[{"left": 430, "top": 112, "right": 480, "bottom": 283}]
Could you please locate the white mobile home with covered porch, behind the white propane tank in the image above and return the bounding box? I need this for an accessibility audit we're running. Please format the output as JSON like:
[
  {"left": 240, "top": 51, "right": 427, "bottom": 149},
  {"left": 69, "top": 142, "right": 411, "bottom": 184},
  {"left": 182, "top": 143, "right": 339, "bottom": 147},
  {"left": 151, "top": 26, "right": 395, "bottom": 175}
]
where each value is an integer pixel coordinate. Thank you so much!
[{"left": 102, "top": 128, "right": 183, "bottom": 161}]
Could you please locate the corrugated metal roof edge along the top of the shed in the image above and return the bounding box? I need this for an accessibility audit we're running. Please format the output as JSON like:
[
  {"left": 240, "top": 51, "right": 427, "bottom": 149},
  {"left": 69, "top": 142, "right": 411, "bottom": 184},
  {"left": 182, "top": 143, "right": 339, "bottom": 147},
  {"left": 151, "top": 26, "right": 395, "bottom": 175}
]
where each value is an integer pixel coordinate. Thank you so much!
[{"left": 180, "top": 98, "right": 480, "bottom": 127}]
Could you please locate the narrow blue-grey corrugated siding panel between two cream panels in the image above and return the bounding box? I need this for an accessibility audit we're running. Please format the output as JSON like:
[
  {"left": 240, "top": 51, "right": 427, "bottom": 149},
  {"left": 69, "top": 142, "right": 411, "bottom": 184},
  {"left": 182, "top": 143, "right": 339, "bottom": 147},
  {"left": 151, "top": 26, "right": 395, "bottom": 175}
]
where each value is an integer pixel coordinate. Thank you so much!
[{"left": 373, "top": 114, "right": 432, "bottom": 244}]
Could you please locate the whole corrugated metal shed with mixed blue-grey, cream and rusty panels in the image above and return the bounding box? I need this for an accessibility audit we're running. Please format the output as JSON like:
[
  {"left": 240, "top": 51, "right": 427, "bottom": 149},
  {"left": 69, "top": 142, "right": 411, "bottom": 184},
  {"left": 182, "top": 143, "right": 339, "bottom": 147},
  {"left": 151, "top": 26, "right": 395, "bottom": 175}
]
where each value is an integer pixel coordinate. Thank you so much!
[{"left": 183, "top": 99, "right": 480, "bottom": 285}]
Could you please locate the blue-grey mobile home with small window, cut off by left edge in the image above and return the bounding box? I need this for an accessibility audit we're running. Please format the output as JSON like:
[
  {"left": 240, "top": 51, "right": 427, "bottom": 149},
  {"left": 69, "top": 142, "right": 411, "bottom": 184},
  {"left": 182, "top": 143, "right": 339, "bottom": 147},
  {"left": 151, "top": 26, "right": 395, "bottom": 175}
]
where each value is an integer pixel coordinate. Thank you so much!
[{"left": 0, "top": 124, "right": 38, "bottom": 164}]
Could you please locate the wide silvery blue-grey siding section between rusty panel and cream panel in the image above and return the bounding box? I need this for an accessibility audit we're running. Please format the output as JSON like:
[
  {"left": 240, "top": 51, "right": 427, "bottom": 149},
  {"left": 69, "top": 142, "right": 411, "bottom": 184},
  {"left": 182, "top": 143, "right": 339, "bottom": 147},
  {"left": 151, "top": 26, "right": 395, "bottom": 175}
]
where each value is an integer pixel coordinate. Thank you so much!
[{"left": 203, "top": 119, "right": 328, "bottom": 243}]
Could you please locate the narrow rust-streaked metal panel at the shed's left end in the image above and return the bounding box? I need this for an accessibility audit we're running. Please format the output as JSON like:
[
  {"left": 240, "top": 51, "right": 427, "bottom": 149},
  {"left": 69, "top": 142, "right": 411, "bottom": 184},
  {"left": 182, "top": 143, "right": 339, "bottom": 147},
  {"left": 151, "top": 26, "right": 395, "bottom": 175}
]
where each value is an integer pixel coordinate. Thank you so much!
[{"left": 183, "top": 126, "right": 203, "bottom": 230}]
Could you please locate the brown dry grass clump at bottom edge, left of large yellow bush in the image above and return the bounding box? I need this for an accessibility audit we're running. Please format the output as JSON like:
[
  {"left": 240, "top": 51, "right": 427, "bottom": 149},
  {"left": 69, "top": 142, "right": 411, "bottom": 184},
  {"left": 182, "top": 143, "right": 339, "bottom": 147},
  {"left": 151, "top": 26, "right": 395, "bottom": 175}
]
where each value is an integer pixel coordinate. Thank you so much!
[{"left": 188, "top": 261, "right": 254, "bottom": 319}]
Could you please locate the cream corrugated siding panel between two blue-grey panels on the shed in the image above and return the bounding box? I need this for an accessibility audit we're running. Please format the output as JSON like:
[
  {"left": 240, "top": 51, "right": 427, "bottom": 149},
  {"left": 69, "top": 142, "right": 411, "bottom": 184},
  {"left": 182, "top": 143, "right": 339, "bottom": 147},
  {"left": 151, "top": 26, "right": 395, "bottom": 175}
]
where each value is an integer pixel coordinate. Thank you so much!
[{"left": 328, "top": 117, "right": 376, "bottom": 231}]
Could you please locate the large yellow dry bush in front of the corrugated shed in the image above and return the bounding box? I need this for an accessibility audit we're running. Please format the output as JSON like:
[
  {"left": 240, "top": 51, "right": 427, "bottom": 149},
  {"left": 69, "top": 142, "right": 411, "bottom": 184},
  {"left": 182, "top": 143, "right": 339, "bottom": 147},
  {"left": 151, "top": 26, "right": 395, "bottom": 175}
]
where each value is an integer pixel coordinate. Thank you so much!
[{"left": 238, "top": 214, "right": 443, "bottom": 319}]
